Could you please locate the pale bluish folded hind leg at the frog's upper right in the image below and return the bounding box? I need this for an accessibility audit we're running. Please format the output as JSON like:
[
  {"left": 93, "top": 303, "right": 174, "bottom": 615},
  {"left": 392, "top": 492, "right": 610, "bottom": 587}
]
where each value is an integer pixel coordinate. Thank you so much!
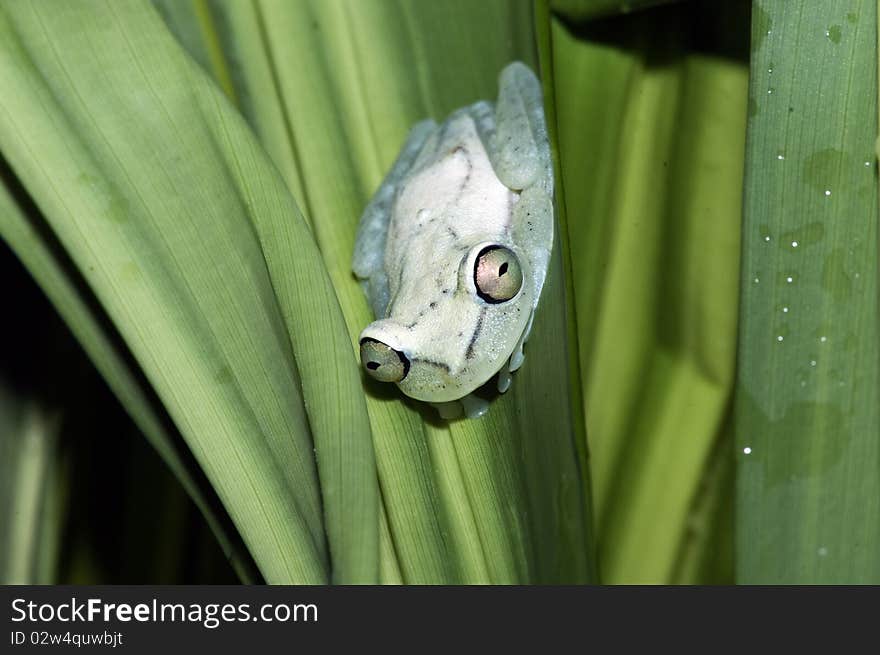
[{"left": 469, "top": 61, "right": 553, "bottom": 195}]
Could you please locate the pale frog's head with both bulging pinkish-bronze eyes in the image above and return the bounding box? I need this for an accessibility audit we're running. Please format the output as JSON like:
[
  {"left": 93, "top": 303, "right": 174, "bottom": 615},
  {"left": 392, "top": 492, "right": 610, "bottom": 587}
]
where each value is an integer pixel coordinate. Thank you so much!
[{"left": 360, "top": 241, "right": 534, "bottom": 402}]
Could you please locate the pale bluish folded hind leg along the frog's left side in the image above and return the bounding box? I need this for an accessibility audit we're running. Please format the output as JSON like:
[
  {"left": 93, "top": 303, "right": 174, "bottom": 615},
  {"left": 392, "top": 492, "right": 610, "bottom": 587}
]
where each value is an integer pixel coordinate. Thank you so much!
[{"left": 351, "top": 120, "right": 437, "bottom": 318}]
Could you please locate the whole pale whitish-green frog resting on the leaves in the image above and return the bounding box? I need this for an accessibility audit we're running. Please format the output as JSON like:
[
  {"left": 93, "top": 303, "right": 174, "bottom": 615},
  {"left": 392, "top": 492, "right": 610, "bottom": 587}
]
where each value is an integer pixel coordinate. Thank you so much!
[{"left": 352, "top": 62, "right": 554, "bottom": 419}]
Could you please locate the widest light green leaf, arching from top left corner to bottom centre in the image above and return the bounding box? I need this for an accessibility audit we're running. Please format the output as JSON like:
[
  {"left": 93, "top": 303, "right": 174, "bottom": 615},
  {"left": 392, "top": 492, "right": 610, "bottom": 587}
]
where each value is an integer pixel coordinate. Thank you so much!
[{"left": 0, "top": 2, "right": 377, "bottom": 582}]
